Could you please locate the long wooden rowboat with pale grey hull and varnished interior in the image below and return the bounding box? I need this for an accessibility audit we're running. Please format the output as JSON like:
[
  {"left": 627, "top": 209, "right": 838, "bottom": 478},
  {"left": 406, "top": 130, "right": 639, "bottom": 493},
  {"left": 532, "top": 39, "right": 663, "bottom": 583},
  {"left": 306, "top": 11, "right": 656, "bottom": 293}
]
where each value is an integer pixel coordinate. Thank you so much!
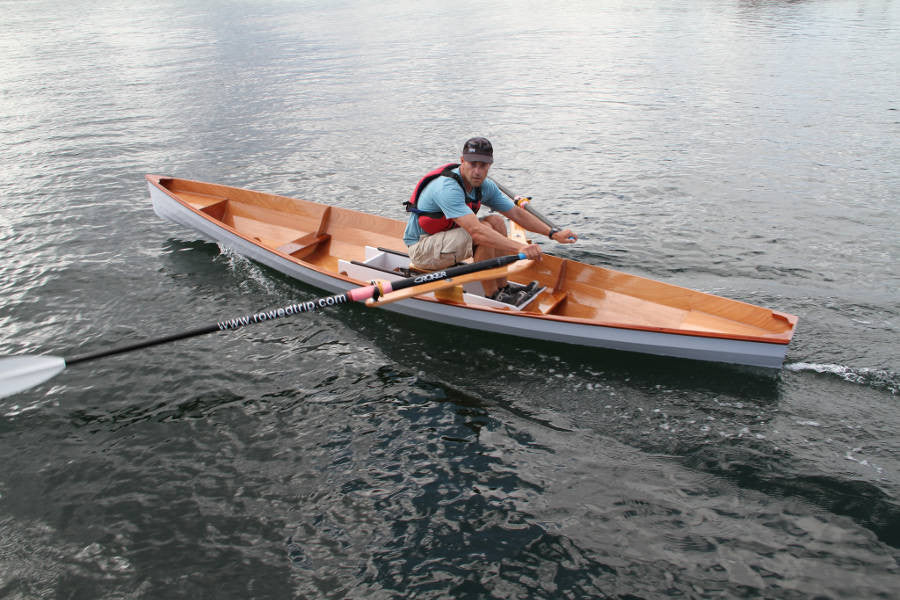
[{"left": 147, "top": 175, "right": 797, "bottom": 369}]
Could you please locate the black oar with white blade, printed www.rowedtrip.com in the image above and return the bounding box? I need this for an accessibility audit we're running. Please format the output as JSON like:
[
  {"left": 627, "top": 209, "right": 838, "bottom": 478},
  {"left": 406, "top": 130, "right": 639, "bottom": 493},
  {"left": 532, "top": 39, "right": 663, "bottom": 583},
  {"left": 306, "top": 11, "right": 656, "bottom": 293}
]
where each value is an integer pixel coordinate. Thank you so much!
[{"left": 0, "top": 254, "right": 525, "bottom": 398}]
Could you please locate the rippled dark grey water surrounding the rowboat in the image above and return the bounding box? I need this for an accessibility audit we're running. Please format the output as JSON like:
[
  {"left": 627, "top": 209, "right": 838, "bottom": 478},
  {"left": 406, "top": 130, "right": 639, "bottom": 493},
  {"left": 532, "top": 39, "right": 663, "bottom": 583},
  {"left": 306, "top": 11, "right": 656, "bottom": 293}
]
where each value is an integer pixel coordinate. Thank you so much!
[{"left": 0, "top": 0, "right": 900, "bottom": 599}]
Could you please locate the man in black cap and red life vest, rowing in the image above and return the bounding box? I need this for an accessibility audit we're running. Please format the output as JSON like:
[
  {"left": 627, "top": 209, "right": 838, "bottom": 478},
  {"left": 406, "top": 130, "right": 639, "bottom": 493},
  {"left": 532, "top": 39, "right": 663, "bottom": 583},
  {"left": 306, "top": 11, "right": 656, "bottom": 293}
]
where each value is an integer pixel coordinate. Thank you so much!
[{"left": 403, "top": 137, "right": 578, "bottom": 297}]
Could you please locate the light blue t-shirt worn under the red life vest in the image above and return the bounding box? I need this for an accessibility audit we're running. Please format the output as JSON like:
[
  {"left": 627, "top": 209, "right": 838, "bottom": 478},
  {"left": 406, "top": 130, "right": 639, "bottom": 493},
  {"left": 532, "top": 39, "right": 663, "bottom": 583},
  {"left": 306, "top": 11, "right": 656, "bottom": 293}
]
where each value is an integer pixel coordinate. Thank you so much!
[{"left": 403, "top": 167, "right": 515, "bottom": 246}]
